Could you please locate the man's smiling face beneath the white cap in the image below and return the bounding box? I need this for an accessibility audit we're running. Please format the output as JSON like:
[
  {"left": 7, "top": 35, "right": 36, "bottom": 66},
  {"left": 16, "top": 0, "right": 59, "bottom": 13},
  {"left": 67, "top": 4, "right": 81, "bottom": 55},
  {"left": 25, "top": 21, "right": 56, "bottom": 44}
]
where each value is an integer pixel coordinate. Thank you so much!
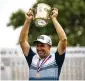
[{"left": 36, "top": 43, "right": 51, "bottom": 58}]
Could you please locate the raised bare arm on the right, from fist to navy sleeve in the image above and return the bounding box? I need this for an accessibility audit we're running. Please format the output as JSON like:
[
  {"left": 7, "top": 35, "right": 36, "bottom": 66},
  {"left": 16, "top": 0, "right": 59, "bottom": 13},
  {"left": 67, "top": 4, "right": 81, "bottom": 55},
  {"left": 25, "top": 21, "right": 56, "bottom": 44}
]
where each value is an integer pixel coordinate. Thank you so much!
[{"left": 51, "top": 8, "right": 67, "bottom": 55}]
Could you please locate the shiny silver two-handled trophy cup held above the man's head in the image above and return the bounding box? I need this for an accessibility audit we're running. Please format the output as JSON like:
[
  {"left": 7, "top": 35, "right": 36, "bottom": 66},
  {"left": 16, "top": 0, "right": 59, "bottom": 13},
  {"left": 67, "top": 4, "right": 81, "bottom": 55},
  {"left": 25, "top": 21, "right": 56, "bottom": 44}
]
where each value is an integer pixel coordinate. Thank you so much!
[{"left": 34, "top": 3, "right": 51, "bottom": 27}]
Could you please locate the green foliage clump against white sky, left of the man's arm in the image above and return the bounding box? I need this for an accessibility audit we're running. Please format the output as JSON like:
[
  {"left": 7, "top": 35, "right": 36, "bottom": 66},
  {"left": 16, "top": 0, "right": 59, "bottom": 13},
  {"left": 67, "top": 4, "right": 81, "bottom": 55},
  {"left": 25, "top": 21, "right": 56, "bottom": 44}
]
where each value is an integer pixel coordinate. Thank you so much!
[{"left": 7, "top": 9, "right": 25, "bottom": 29}]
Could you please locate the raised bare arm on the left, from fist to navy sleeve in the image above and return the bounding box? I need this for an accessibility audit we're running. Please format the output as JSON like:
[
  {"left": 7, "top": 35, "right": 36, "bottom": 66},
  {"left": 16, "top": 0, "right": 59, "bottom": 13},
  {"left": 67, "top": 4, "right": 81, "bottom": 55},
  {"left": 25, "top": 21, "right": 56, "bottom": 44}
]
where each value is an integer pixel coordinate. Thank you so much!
[{"left": 19, "top": 9, "right": 33, "bottom": 56}]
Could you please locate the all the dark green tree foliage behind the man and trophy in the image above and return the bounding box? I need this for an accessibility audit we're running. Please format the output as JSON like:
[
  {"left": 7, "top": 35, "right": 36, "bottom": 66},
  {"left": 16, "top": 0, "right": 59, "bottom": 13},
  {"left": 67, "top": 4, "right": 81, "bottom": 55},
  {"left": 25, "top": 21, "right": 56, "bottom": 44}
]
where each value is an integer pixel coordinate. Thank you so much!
[{"left": 7, "top": 0, "right": 85, "bottom": 46}]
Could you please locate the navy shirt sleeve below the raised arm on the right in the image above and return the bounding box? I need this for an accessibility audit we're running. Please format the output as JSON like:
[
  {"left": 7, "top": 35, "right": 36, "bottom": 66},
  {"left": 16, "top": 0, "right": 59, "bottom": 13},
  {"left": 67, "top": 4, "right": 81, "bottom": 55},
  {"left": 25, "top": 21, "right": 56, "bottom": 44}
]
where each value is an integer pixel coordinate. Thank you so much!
[{"left": 55, "top": 51, "right": 65, "bottom": 67}]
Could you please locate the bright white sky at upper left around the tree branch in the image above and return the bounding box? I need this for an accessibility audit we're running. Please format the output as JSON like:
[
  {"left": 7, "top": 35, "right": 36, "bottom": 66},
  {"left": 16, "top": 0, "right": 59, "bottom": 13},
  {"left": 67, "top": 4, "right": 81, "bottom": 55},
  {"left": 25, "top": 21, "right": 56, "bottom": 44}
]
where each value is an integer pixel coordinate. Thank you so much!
[{"left": 0, "top": 0, "right": 36, "bottom": 48}]
